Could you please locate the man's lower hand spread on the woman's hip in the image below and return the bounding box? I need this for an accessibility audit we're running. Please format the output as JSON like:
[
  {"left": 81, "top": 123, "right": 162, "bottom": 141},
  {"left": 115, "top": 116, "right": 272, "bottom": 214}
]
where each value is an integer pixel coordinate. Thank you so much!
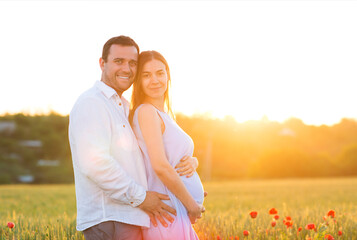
[{"left": 138, "top": 191, "right": 176, "bottom": 227}]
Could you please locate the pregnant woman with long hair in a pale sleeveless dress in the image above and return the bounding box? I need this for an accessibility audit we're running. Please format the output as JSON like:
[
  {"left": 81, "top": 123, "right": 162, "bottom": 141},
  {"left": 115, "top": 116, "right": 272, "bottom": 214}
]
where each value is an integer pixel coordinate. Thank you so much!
[{"left": 129, "top": 51, "right": 204, "bottom": 240}]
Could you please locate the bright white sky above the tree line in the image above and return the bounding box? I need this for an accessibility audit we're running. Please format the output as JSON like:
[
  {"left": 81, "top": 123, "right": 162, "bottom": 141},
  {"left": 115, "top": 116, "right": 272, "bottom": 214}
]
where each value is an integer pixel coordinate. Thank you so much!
[{"left": 0, "top": 0, "right": 357, "bottom": 125}]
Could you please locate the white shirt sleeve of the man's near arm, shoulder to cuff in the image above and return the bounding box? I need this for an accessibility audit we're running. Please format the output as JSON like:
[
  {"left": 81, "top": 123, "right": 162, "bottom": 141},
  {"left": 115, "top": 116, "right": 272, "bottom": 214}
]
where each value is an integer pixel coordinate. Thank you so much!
[{"left": 70, "top": 98, "right": 146, "bottom": 207}]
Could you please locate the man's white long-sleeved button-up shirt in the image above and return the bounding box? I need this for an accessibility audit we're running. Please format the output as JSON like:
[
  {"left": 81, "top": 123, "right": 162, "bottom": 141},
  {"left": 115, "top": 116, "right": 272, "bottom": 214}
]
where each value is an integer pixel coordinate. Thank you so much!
[{"left": 69, "top": 81, "right": 150, "bottom": 231}]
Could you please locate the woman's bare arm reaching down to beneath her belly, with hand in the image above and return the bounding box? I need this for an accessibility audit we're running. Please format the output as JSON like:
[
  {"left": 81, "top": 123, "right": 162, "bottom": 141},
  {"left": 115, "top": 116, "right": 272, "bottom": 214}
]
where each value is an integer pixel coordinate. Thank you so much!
[{"left": 138, "top": 104, "right": 202, "bottom": 223}]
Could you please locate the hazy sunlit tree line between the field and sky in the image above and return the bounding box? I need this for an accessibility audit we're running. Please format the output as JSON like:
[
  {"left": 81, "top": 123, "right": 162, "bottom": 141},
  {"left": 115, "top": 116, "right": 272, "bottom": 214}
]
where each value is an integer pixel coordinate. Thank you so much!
[{"left": 0, "top": 112, "right": 357, "bottom": 183}]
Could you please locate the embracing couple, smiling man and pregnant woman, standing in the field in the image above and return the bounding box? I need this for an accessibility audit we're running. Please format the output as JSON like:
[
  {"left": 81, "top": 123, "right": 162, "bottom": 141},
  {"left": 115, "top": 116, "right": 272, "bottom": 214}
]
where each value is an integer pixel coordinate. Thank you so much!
[{"left": 69, "top": 36, "right": 204, "bottom": 240}]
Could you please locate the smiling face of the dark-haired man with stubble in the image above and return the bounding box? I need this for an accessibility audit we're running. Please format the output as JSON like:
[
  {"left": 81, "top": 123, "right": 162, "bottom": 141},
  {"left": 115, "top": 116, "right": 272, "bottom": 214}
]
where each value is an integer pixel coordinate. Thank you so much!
[{"left": 99, "top": 45, "right": 138, "bottom": 96}]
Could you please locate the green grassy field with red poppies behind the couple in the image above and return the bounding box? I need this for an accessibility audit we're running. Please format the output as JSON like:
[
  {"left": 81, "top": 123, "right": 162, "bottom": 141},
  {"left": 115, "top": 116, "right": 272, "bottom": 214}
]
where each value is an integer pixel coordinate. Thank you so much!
[{"left": 0, "top": 178, "right": 357, "bottom": 240}]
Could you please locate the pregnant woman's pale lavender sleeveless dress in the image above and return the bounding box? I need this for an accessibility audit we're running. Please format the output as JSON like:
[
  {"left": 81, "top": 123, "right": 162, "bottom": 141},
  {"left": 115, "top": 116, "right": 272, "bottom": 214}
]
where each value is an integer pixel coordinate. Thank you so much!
[{"left": 133, "top": 105, "right": 204, "bottom": 240}]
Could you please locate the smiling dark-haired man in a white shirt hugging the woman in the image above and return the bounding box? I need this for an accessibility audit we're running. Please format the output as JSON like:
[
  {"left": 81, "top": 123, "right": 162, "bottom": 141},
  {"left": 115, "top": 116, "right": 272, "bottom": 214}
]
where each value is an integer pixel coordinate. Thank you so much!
[{"left": 69, "top": 36, "right": 198, "bottom": 240}]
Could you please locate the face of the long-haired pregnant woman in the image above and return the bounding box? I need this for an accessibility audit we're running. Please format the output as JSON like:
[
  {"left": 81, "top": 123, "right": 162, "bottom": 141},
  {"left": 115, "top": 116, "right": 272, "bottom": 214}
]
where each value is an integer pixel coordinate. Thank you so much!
[{"left": 140, "top": 59, "right": 168, "bottom": 100}]
